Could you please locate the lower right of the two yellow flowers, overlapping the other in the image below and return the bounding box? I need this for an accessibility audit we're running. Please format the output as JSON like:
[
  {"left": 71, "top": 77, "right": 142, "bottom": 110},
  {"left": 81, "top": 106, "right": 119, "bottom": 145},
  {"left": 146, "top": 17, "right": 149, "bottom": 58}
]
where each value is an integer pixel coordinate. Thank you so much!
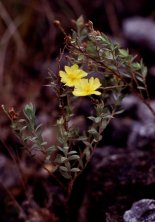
[{"left": 73, "top": 77, "right": 101, "bottom": 96}]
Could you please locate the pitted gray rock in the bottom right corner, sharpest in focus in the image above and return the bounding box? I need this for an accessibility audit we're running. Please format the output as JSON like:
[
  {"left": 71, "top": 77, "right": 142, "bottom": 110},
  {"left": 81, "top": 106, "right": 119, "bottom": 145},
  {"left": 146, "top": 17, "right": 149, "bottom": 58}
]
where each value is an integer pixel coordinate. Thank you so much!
[{"left": 123, "top": 199, "right": 155, "bottom": 222}]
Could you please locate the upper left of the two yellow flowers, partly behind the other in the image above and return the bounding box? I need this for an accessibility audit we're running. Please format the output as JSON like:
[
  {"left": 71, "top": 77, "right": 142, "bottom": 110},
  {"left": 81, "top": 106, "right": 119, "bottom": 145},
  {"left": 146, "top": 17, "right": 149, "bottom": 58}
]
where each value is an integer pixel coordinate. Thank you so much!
[{"left": 59, "top": 64, "right": 88, "bottom": 86}]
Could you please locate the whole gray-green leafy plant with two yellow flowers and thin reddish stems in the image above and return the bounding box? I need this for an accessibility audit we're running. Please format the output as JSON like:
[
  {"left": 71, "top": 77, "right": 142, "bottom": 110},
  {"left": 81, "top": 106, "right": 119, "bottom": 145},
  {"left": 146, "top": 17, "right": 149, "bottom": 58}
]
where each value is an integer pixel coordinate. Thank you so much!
[{"left": 4, "top": 17, "right": 151, "bottom": 189}]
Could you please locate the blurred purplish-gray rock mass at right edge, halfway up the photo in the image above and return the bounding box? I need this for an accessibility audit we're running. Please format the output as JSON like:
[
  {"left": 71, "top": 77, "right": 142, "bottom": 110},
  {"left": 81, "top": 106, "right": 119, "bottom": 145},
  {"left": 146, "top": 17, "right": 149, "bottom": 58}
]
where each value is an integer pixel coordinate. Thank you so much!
[{"left": 122, "top": 95, "right": 155, "bottom": 148}]
